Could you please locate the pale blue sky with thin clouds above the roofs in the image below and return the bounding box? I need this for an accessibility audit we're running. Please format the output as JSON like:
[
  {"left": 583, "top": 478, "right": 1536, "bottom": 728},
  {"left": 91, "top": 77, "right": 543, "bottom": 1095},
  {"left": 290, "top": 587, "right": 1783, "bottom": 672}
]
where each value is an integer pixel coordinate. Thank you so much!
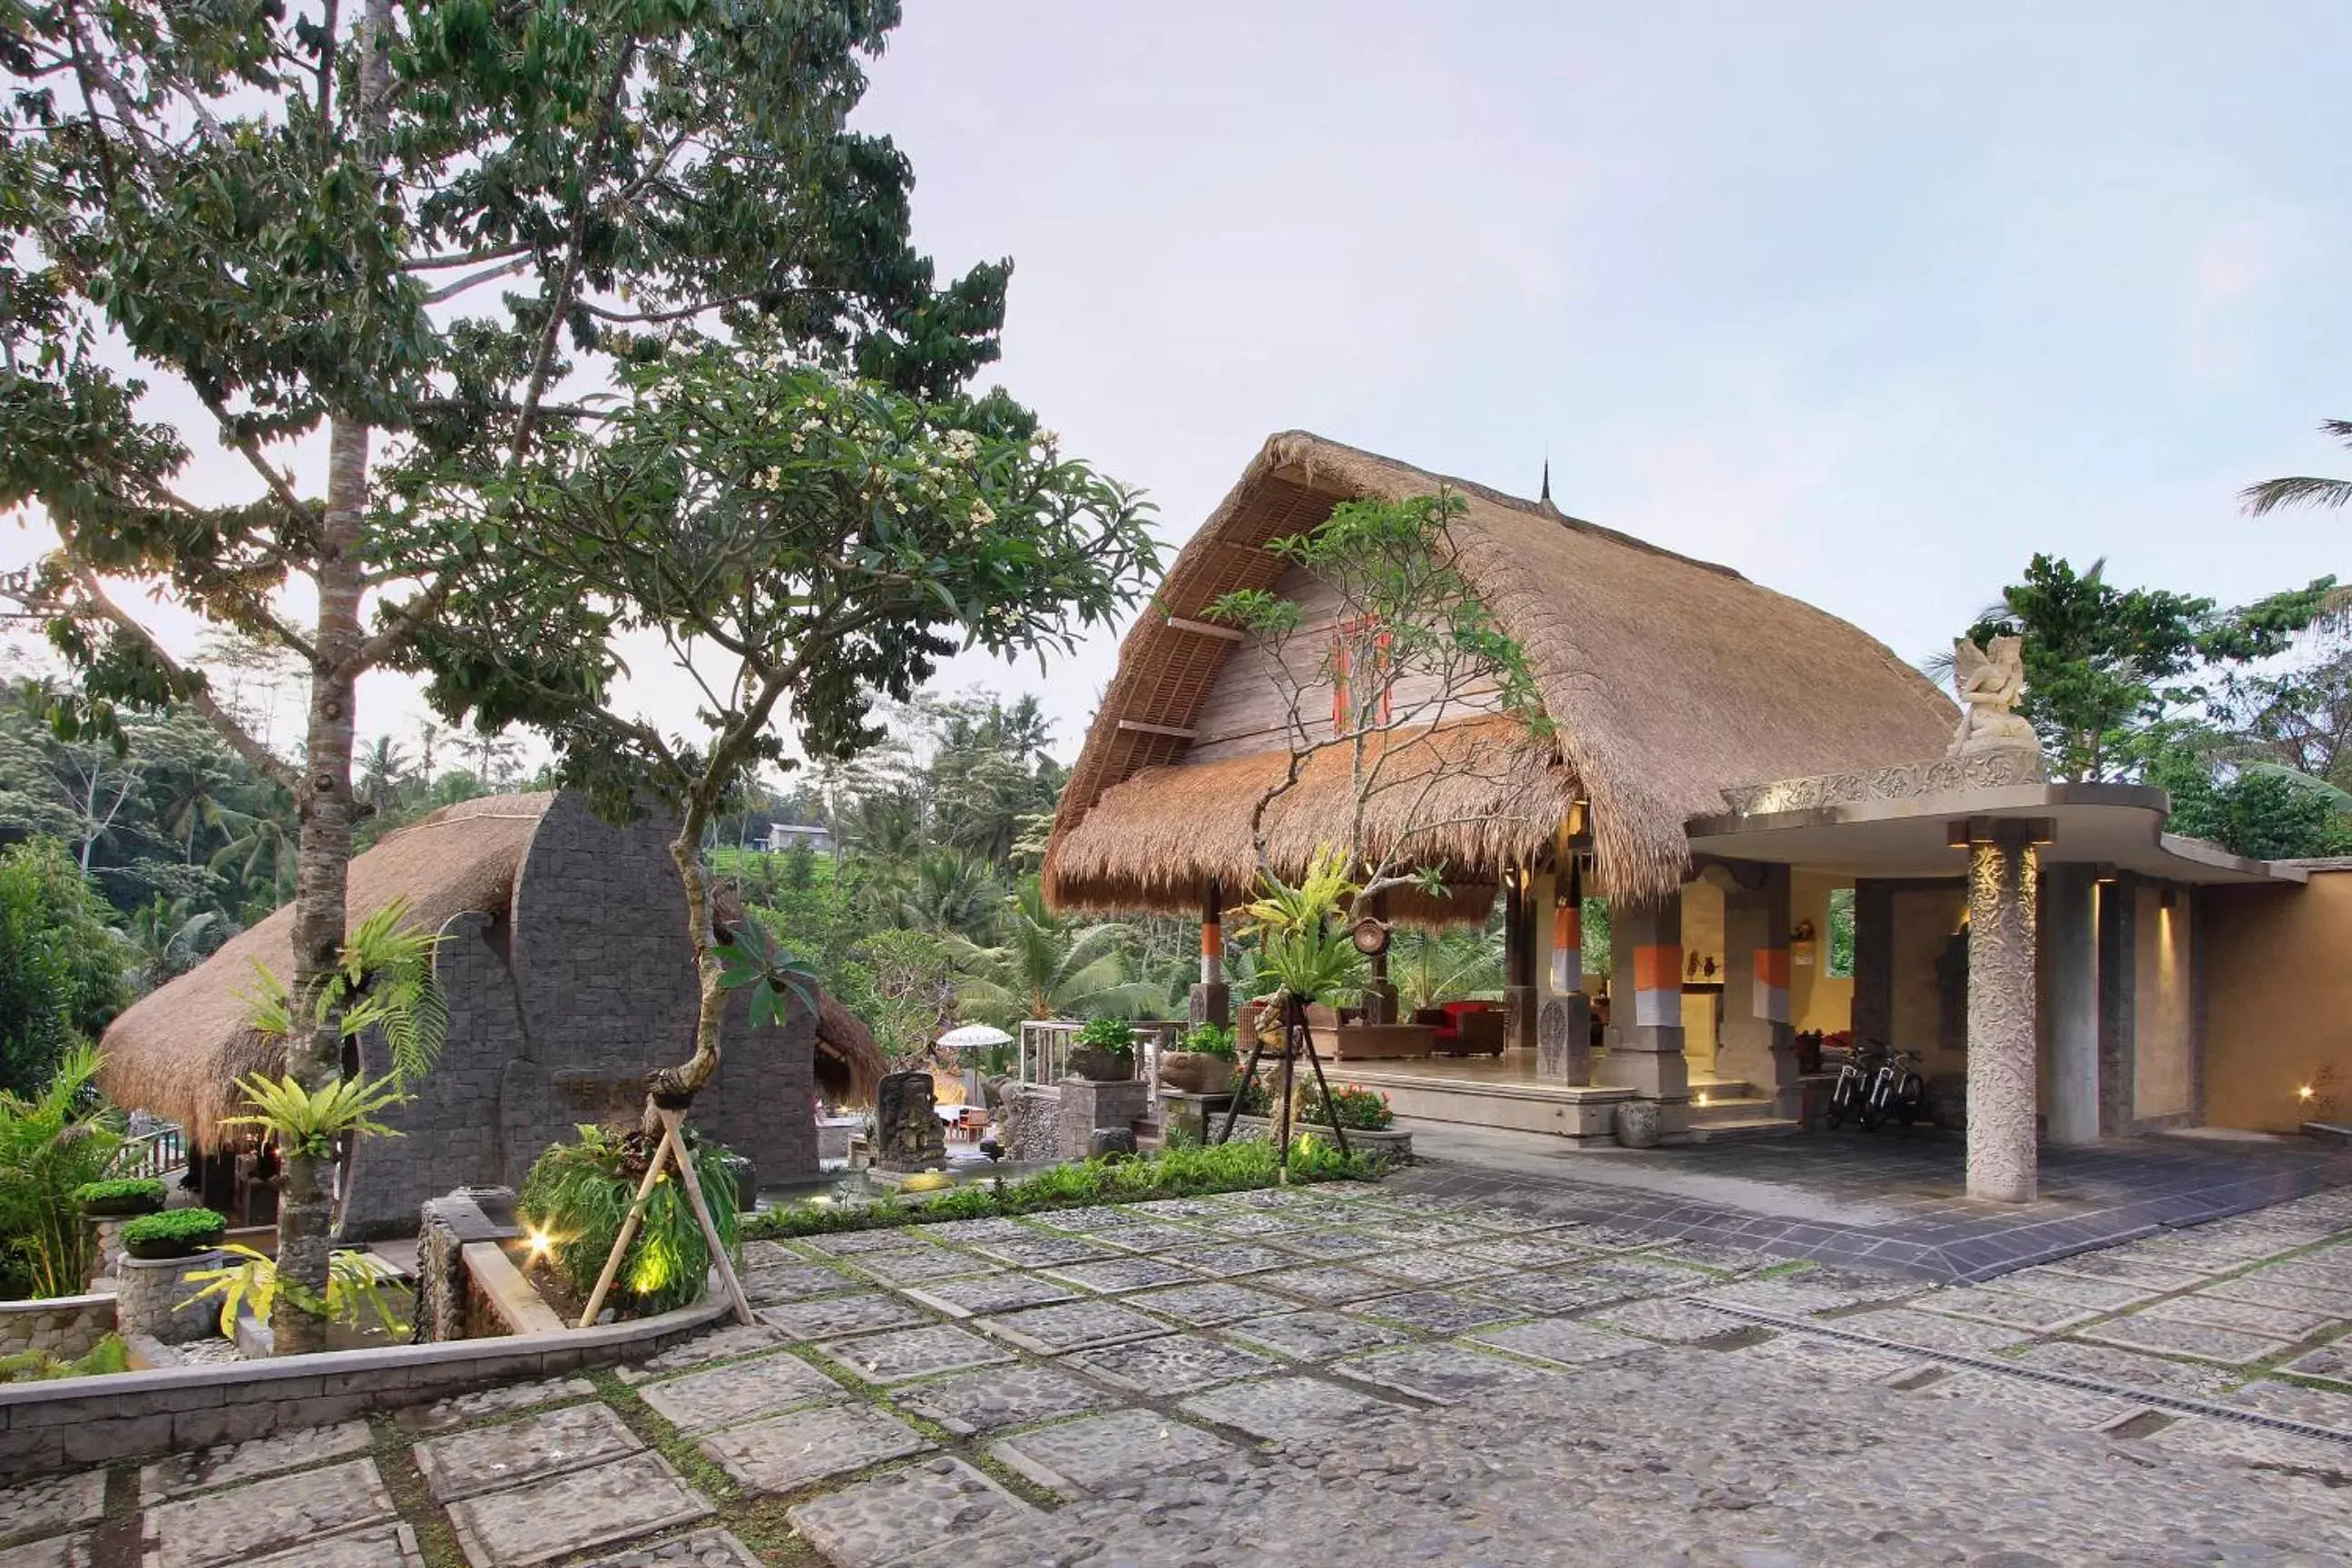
[{"left": 0, "top": 0, "right": 2352, "bottom": 757}]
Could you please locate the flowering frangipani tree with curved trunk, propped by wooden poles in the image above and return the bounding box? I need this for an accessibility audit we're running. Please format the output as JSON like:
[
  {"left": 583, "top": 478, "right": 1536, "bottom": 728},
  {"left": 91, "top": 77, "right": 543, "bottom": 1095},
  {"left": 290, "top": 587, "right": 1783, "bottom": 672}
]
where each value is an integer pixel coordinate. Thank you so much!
[{"left": 416, "top": 346, "right": 1157, "bottom": 1098}]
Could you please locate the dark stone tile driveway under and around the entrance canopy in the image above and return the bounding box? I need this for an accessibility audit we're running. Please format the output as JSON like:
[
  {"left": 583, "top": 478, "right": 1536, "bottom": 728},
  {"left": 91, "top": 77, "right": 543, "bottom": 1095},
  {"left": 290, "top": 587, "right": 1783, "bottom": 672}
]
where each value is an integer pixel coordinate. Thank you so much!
[{"left": 1392, "top": 1122, "right": 2352, "bottom": 1281}]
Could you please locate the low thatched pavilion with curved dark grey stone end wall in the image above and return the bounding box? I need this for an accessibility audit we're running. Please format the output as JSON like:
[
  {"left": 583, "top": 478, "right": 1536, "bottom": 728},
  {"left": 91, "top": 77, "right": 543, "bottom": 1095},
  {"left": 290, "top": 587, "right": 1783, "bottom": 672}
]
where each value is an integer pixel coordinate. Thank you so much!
[{"left": 99, "top": 792, "right": 885, "bottom": 1227}]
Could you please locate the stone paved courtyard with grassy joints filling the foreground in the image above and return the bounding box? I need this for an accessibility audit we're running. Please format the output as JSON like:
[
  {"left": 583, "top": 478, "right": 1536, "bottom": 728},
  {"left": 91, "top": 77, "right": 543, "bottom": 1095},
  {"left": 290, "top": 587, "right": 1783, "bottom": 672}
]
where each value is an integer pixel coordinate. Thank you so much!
[{"left": 0, "top": 1171, "right": 2352, "bottom": 1568}]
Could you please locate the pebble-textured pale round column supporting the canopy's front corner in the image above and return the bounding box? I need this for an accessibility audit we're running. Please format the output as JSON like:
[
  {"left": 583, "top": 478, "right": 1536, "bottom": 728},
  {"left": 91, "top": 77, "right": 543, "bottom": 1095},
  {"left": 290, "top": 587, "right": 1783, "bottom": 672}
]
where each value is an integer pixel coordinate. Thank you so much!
[{"left": 1969, "top": 820, "right": 2039, "bottom": 1203}]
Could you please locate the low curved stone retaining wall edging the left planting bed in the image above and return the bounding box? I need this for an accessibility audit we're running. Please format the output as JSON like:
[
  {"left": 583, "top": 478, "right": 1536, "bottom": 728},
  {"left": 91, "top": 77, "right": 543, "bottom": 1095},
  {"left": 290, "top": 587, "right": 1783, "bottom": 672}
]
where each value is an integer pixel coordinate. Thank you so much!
[{"left": 0, "top": 1290, "right": 730, "bottom": 1481}]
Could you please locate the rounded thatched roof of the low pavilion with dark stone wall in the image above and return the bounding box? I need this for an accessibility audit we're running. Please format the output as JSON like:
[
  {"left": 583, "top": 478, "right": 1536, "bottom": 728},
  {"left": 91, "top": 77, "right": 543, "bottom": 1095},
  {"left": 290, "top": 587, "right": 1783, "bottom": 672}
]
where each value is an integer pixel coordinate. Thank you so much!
[{"left": 99, "top": 792, "right": 882, "bottom": 1147}]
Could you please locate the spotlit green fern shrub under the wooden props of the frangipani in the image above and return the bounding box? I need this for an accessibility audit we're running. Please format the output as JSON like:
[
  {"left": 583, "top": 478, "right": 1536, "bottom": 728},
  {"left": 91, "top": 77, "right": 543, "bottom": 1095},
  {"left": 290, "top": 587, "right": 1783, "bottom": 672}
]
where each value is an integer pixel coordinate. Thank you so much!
[{"left": 520, "top": 1126, "right": 739, "bottom": 1317}]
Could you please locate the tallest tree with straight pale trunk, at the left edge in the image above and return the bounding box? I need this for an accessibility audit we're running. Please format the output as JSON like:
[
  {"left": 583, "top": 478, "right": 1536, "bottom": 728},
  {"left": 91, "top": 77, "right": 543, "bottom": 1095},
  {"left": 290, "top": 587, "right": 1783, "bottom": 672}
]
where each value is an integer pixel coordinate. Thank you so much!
[{"left": 0, "top": 0, "right": 1006, "bottom": 1352}]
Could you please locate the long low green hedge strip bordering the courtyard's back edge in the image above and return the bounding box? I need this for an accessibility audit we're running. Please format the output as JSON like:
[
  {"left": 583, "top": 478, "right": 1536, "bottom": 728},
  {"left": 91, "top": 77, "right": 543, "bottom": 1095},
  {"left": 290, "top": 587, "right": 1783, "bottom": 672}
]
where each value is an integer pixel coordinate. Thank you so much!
[{"left": 743, "top": 1138, "right": 1378, "bottom": 1241}]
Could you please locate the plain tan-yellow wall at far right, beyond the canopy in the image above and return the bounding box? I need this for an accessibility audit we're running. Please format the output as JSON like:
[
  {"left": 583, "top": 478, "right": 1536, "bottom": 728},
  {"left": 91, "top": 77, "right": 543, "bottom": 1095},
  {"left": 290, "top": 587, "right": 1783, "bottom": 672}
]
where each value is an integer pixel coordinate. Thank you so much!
[{"left": 2200, "top": 872, "right": 2352, "bottom": 1133}]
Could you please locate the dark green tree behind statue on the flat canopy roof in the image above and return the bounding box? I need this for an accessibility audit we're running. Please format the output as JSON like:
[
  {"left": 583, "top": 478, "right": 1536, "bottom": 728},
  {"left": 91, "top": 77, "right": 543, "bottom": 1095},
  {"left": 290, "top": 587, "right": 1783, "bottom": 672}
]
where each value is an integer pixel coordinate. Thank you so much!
[{"left": 1969, "top": 554, "right": 2340, "bottom": 780}]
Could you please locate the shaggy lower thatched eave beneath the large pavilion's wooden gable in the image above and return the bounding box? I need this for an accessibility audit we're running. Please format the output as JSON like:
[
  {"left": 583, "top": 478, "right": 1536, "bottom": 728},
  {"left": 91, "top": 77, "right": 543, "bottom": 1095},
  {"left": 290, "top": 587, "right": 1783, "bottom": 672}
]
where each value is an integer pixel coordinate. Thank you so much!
[{"left": 1054, "top": 720, "right": 1576, "bottom": 924}]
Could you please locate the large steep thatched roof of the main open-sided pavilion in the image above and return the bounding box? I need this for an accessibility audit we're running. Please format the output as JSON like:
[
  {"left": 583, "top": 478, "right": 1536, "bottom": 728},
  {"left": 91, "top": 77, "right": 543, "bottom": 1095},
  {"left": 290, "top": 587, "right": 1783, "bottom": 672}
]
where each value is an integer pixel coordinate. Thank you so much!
[{"left": 1044, "top": 430, "right": 1955, "bottom": 910}]
